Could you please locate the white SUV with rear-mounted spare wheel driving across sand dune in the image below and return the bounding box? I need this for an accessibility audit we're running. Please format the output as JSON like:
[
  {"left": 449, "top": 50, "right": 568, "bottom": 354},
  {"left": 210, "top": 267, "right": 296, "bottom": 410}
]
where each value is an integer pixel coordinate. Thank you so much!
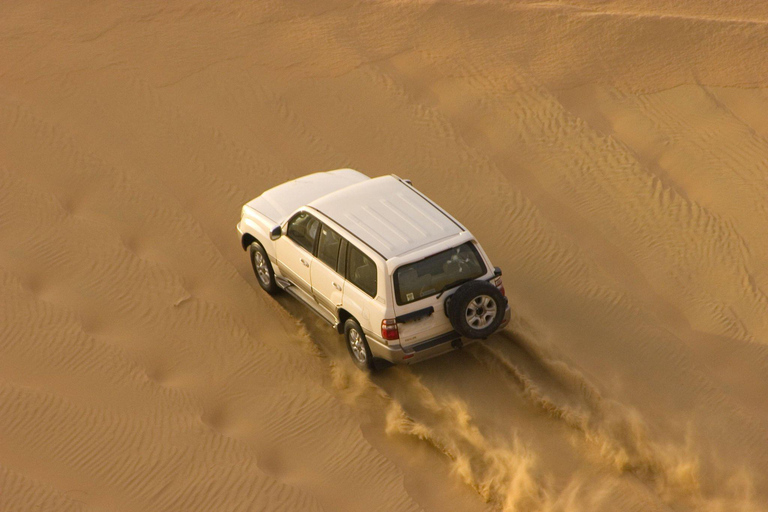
[{"left": 237, "top": 169, "right": 510, "bottom": 369}]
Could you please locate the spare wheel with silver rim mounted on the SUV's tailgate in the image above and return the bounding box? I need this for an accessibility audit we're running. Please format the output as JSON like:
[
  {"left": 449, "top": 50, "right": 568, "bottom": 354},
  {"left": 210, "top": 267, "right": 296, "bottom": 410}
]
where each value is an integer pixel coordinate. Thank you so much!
[{"left": 445, "top": 281, "right": 507, "bottom": 339}]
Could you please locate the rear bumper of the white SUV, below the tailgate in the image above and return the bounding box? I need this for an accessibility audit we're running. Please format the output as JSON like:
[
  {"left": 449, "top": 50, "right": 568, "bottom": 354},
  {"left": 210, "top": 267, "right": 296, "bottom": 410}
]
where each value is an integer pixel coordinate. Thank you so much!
[{"left": 365, "top": 305, "right": 512, "bottom": 364}]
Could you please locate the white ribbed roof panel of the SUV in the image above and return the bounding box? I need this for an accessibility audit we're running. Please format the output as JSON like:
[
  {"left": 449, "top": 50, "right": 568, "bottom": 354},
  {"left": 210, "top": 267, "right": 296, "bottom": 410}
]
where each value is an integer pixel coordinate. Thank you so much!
[{"left": 307, "top": 176, "right": 466, "bottom": 259}]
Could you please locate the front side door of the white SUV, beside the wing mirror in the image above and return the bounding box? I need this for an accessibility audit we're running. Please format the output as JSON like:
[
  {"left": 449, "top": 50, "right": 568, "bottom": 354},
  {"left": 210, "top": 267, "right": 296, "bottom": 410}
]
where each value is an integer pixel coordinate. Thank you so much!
[{"left": 275, "top": 211, "right": 320, "bottom": 297}]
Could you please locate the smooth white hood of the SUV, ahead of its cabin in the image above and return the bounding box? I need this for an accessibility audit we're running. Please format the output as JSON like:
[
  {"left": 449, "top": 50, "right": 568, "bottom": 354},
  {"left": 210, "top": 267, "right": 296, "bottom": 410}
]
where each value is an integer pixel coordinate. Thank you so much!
[{"left": 247, "top": 169, "right": 370, "bottom": 224}]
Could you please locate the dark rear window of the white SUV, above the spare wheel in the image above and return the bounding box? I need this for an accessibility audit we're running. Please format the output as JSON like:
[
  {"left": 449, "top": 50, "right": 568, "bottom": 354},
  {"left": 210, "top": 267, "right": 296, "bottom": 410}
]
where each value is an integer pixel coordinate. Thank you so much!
[{"left": 395, "top": 242, "right": 485, "bottom": 306}]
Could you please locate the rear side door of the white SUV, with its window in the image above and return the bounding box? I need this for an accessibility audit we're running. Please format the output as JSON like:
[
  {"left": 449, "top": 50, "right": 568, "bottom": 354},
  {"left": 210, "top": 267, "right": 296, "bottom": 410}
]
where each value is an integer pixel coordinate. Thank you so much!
[{"left": 311, "top": 224, "right": 347, "bottom": 317}]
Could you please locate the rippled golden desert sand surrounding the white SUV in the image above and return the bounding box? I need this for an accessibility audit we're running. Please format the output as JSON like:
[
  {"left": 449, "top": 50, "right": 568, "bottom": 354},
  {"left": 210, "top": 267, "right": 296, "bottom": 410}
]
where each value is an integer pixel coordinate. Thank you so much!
[{"left": 0, "top": 0, "right": 768, "bottom": 512}]
